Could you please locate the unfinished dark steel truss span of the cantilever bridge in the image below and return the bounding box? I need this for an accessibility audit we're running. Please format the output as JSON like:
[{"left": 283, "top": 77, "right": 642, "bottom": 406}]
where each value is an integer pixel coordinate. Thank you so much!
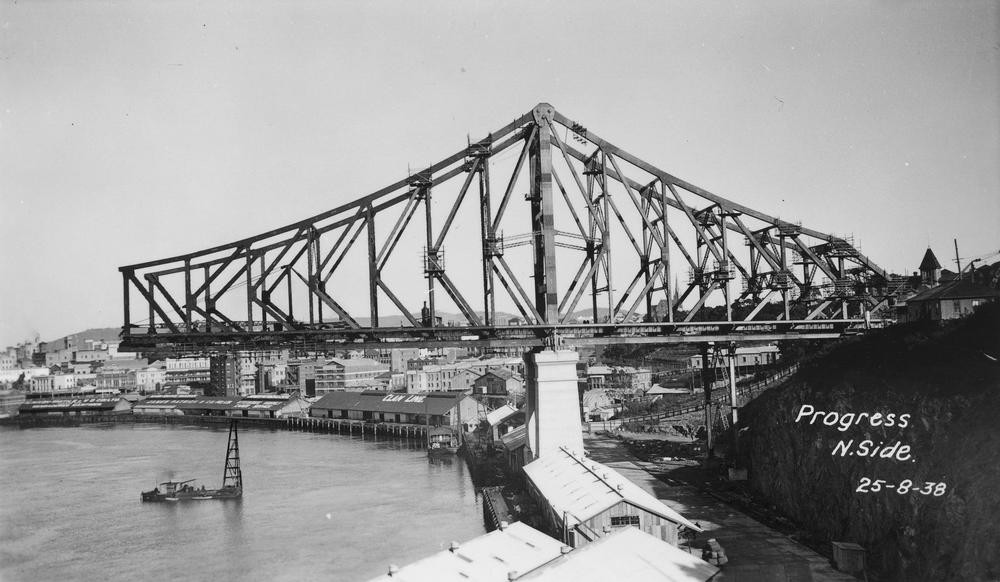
[{"left": 119, "top": 103, "right": 889, "bottom": 353}]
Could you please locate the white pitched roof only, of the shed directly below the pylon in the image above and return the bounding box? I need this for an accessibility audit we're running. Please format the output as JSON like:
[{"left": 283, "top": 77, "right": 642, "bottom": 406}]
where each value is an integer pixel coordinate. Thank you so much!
[{"left": 524, "top": 448, "right": 702, "bottom": 531}]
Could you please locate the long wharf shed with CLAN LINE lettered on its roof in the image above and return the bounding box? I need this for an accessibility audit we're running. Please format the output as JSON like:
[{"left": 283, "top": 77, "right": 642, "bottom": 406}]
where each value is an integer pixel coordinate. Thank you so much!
[{"left": 309, "top": 391, "right": 479, "bottom": 428}]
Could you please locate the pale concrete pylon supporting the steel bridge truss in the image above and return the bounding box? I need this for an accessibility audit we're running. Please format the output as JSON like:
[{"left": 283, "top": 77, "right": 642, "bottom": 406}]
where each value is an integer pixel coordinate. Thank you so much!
[{"left": 524, "top": 349, "right": 583, "bottom": 462}]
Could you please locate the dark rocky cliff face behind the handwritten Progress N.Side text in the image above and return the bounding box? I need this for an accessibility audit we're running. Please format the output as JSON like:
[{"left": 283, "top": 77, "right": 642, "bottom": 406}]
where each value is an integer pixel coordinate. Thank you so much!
[{"left": 740, "top": 306, "right": 1000, "bottom": 581}]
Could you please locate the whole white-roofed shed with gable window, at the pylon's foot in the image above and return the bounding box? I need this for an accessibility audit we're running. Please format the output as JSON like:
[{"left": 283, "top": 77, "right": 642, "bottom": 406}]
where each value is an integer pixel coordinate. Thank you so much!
[{"left": 524, "top": 447, "right": 702, "bottom": 547}]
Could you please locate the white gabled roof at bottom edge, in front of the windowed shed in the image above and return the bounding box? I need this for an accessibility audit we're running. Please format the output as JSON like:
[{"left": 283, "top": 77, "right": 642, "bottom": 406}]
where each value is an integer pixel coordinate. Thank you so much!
[{"left": 518, "top": 527, "right": 719, "bottom": 582}]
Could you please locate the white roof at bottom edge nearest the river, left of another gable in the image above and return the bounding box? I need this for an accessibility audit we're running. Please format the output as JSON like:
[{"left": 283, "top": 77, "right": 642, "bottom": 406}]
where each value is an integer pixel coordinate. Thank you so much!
[{"left": 371, "top": 522, "right": 563, "bottom": 582}]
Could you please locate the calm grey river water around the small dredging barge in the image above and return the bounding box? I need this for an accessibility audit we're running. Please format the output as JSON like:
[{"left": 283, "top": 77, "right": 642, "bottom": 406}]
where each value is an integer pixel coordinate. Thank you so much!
[{"left": 0, "top": 424, "right": 484, "bottom": 582}]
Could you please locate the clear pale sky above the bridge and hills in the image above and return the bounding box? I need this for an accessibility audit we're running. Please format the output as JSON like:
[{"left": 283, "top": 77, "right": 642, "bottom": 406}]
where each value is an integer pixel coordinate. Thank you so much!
[{"left": 0, "top": 0, "right": 1000, "bottom": 346}]
